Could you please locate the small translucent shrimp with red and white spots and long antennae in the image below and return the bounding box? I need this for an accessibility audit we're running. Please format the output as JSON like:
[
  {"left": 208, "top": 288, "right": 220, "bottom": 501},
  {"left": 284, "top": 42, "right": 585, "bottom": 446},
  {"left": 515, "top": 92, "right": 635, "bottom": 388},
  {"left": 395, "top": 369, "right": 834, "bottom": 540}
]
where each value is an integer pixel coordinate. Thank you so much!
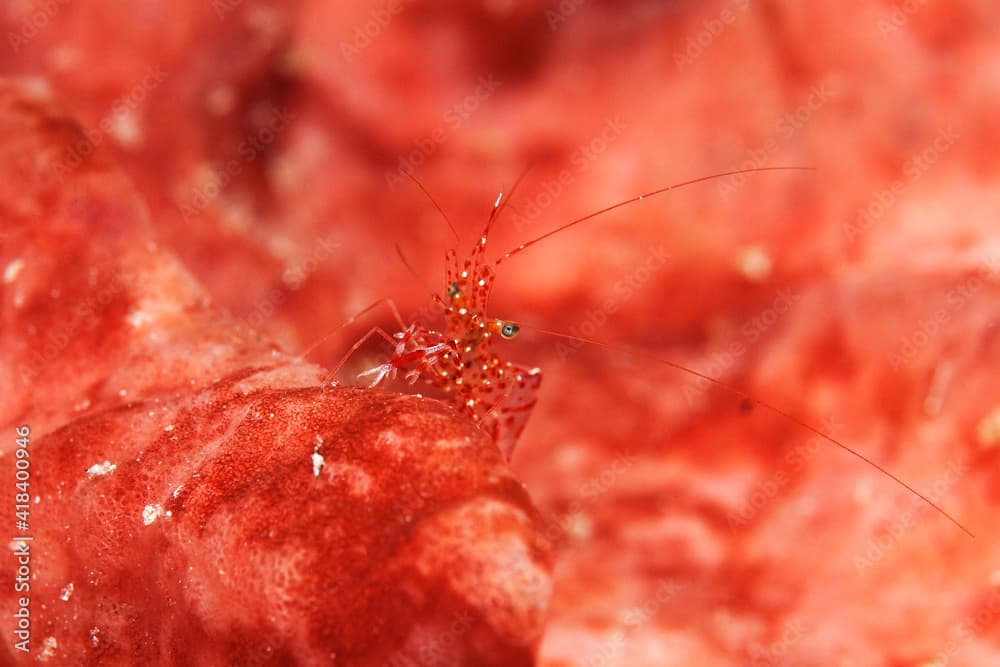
[{"left": 303, "top": 167, "right": 975, "bottom": 537}]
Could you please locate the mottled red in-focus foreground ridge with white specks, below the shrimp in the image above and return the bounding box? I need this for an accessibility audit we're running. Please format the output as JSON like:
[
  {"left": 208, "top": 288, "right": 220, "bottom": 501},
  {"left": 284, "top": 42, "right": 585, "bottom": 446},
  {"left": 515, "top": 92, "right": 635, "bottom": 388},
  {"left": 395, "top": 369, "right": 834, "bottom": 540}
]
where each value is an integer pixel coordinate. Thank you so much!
[{"left": 0, "top": 85, "right": 550, "bottom": 665}]
